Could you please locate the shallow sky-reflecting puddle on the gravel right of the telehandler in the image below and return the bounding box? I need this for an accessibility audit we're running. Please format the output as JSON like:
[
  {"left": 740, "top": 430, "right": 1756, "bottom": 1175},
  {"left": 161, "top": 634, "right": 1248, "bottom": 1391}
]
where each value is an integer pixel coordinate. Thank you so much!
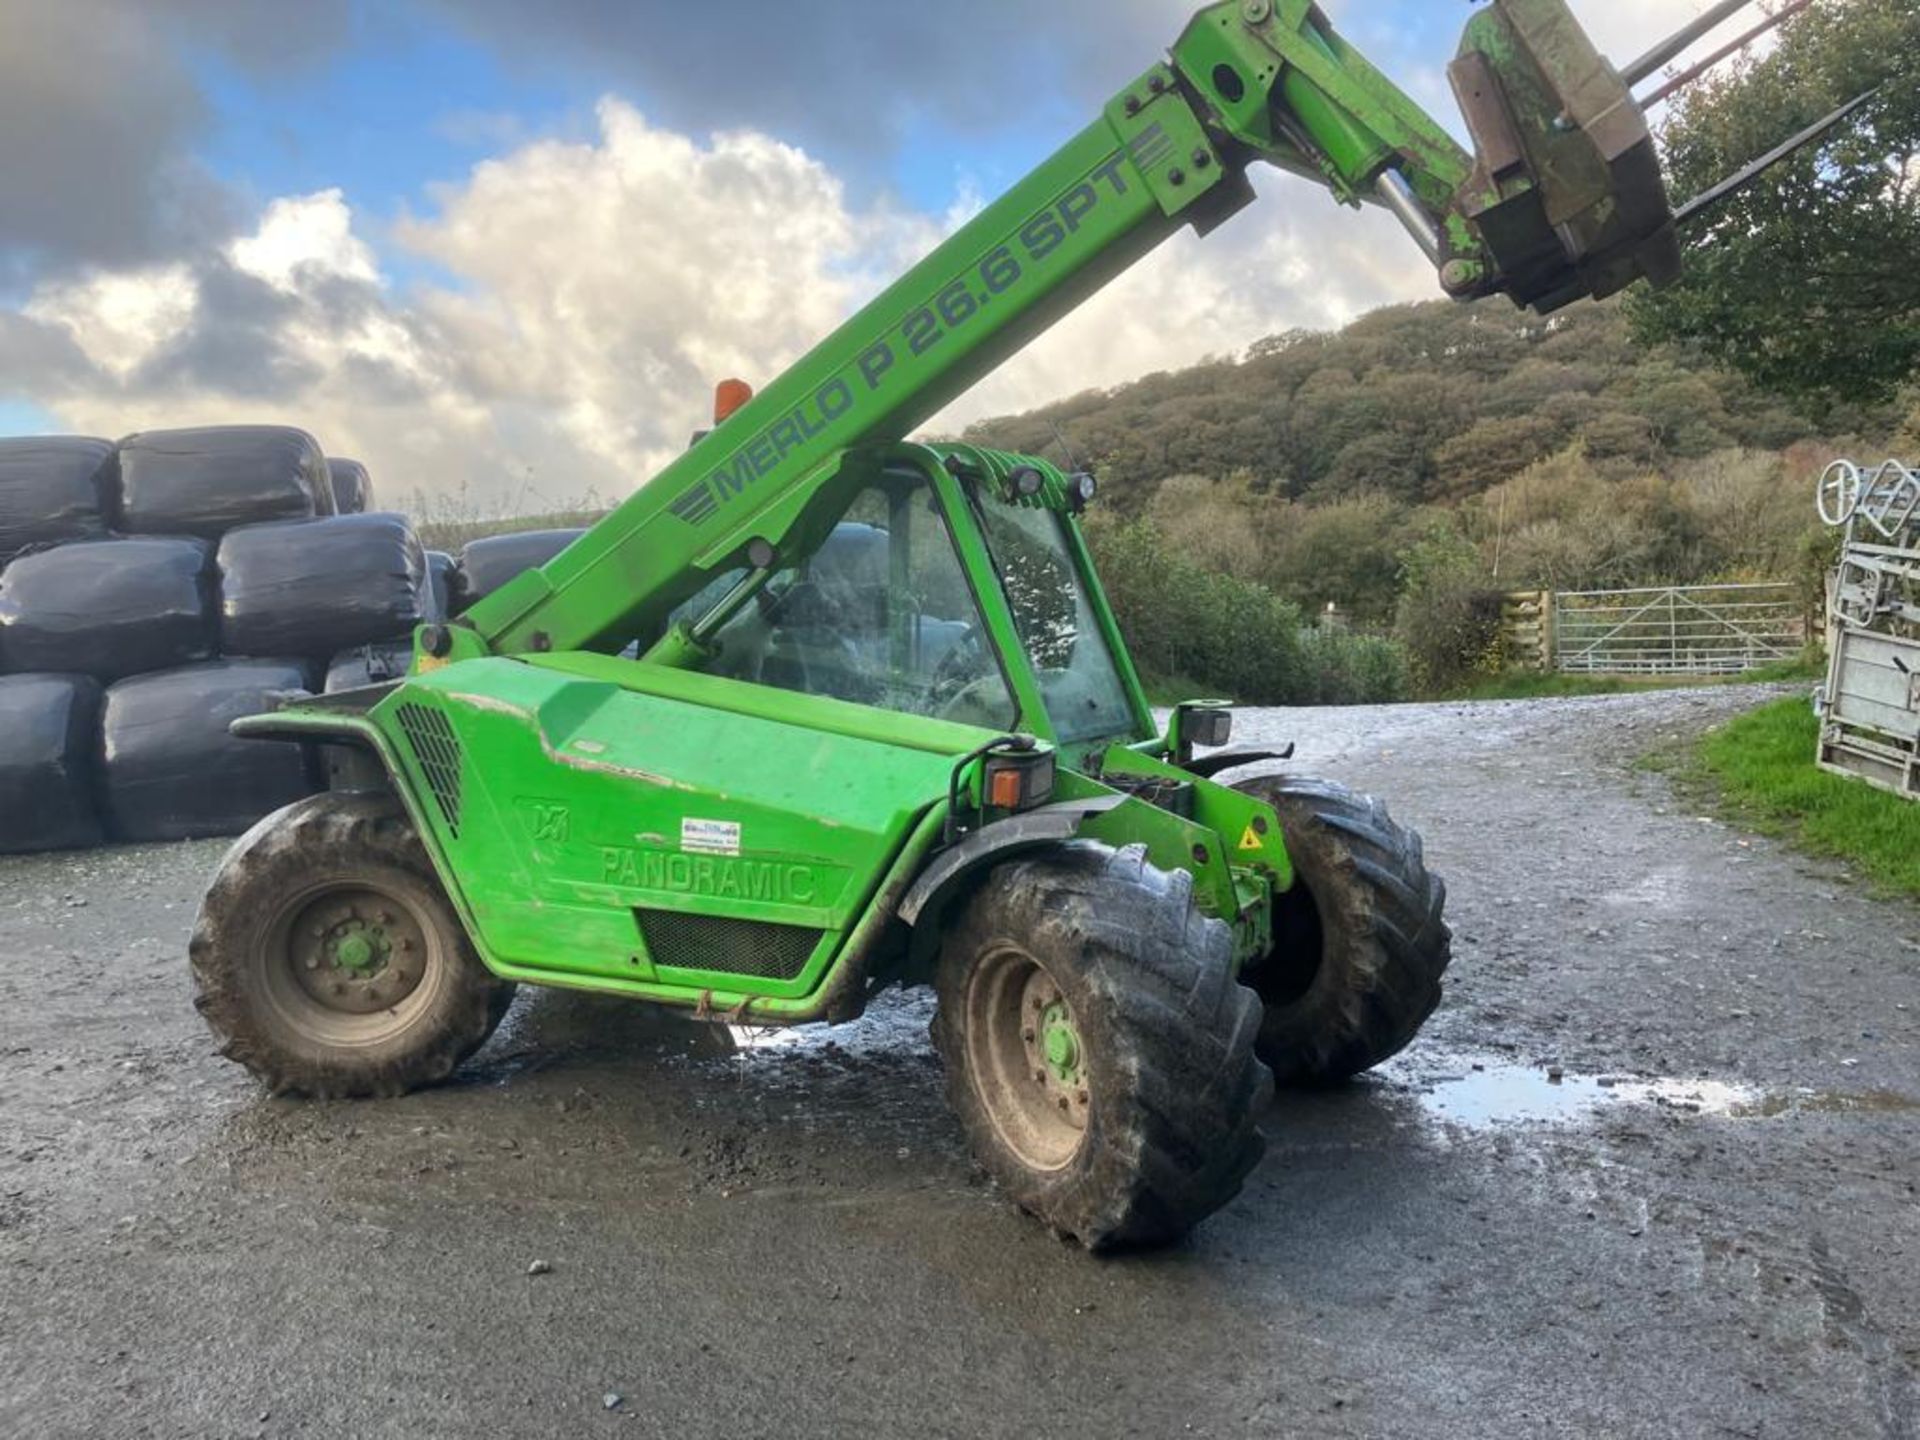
[{"left": 1409, "top": 1060, "right": 1920, "bottom": 1129}]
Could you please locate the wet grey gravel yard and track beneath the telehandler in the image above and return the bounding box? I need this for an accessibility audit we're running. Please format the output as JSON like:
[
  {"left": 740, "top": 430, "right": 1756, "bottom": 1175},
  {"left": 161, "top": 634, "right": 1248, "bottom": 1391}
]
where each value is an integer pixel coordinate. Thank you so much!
[{"left": 0, "top": 689, "right": 1920, "bottom": 1438}]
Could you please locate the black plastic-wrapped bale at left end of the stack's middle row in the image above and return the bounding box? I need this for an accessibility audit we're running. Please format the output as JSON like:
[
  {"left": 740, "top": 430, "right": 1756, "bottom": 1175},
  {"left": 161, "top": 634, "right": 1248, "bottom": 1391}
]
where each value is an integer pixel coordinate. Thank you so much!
[{"left": 0, "top": 538, "right": 217, "bottom": 682}]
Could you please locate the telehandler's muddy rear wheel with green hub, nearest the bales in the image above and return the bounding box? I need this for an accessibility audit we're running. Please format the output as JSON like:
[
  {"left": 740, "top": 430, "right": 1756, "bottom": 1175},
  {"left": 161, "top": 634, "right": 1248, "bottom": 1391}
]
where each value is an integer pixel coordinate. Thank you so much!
[{"left": 190, "top": 795, "right": 515, "bottom": 1100}]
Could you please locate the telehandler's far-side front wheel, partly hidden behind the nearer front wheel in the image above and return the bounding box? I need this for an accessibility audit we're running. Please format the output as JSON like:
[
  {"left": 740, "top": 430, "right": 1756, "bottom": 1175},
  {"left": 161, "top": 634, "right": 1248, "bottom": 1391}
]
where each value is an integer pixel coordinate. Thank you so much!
[{"left": 1236, "top": 776, "right": 1453, "bottom": 1085}]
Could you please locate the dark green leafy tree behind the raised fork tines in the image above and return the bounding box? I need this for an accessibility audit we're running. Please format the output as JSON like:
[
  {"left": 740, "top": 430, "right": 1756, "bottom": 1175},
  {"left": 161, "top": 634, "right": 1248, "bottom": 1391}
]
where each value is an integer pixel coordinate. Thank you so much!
[{"left": 1630, "top": 0, "right": 1920, "bottom": 407}]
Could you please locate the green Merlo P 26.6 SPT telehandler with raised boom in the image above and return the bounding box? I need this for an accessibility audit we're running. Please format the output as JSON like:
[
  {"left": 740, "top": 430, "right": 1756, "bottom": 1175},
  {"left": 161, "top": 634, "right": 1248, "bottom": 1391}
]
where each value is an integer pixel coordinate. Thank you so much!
[{"left": 192, "top": 0, "right": 1751, "bottom": 1250}]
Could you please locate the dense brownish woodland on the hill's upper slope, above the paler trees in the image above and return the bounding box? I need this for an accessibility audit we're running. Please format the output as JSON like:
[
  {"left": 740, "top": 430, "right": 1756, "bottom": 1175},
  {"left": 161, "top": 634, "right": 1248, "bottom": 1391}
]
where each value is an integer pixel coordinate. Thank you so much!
[{"left": 968, "top": 300, "right": 1899, "bottom": 509}]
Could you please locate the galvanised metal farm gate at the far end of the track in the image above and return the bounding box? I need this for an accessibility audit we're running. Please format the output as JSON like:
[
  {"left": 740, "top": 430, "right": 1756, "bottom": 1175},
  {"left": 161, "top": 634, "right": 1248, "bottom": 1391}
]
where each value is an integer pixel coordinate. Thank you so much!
[{"left": 1553, "top": 586, "right": 1807, "bottom": 676}]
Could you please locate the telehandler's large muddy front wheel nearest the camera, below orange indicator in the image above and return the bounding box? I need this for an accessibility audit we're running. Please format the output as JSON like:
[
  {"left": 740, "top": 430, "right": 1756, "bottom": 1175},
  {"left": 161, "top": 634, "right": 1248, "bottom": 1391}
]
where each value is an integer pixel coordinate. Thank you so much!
[{"left": 933, "top": 843, "right": 1273, "bottom": 1250}]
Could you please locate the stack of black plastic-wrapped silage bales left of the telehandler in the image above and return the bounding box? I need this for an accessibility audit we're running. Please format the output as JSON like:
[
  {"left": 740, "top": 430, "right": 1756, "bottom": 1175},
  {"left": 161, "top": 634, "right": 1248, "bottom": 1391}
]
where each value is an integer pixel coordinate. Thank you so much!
[{"left": 0, "top": 426, "right": 435, "bottom": 852}]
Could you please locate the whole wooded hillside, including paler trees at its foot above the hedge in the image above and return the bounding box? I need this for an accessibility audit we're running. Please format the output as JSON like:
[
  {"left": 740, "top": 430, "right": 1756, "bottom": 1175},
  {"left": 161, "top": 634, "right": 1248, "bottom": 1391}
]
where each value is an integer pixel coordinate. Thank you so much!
[{"left": 968, "top": 301, "right": 1920, "bottom": 624}]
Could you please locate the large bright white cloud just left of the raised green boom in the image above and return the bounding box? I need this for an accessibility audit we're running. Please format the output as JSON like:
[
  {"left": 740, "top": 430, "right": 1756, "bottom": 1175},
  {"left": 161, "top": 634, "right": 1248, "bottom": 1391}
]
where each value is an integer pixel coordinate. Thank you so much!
[{"left": 397, "top": 100, "right": 933, "bottom": 491}]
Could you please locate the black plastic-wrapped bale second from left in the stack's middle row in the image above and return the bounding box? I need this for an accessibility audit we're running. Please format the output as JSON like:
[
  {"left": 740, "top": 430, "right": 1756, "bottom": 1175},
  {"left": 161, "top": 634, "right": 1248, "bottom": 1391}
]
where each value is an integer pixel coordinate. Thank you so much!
[{"left": 219, "top": 515, "right": 426, "bottom": 660}]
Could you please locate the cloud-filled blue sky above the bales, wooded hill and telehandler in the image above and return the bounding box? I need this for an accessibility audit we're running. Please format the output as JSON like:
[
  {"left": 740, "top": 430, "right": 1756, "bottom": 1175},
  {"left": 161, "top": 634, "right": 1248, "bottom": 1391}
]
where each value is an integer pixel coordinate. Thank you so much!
[{"left": 0, "top": 0, "right": 1705, "bottom": 501}]
